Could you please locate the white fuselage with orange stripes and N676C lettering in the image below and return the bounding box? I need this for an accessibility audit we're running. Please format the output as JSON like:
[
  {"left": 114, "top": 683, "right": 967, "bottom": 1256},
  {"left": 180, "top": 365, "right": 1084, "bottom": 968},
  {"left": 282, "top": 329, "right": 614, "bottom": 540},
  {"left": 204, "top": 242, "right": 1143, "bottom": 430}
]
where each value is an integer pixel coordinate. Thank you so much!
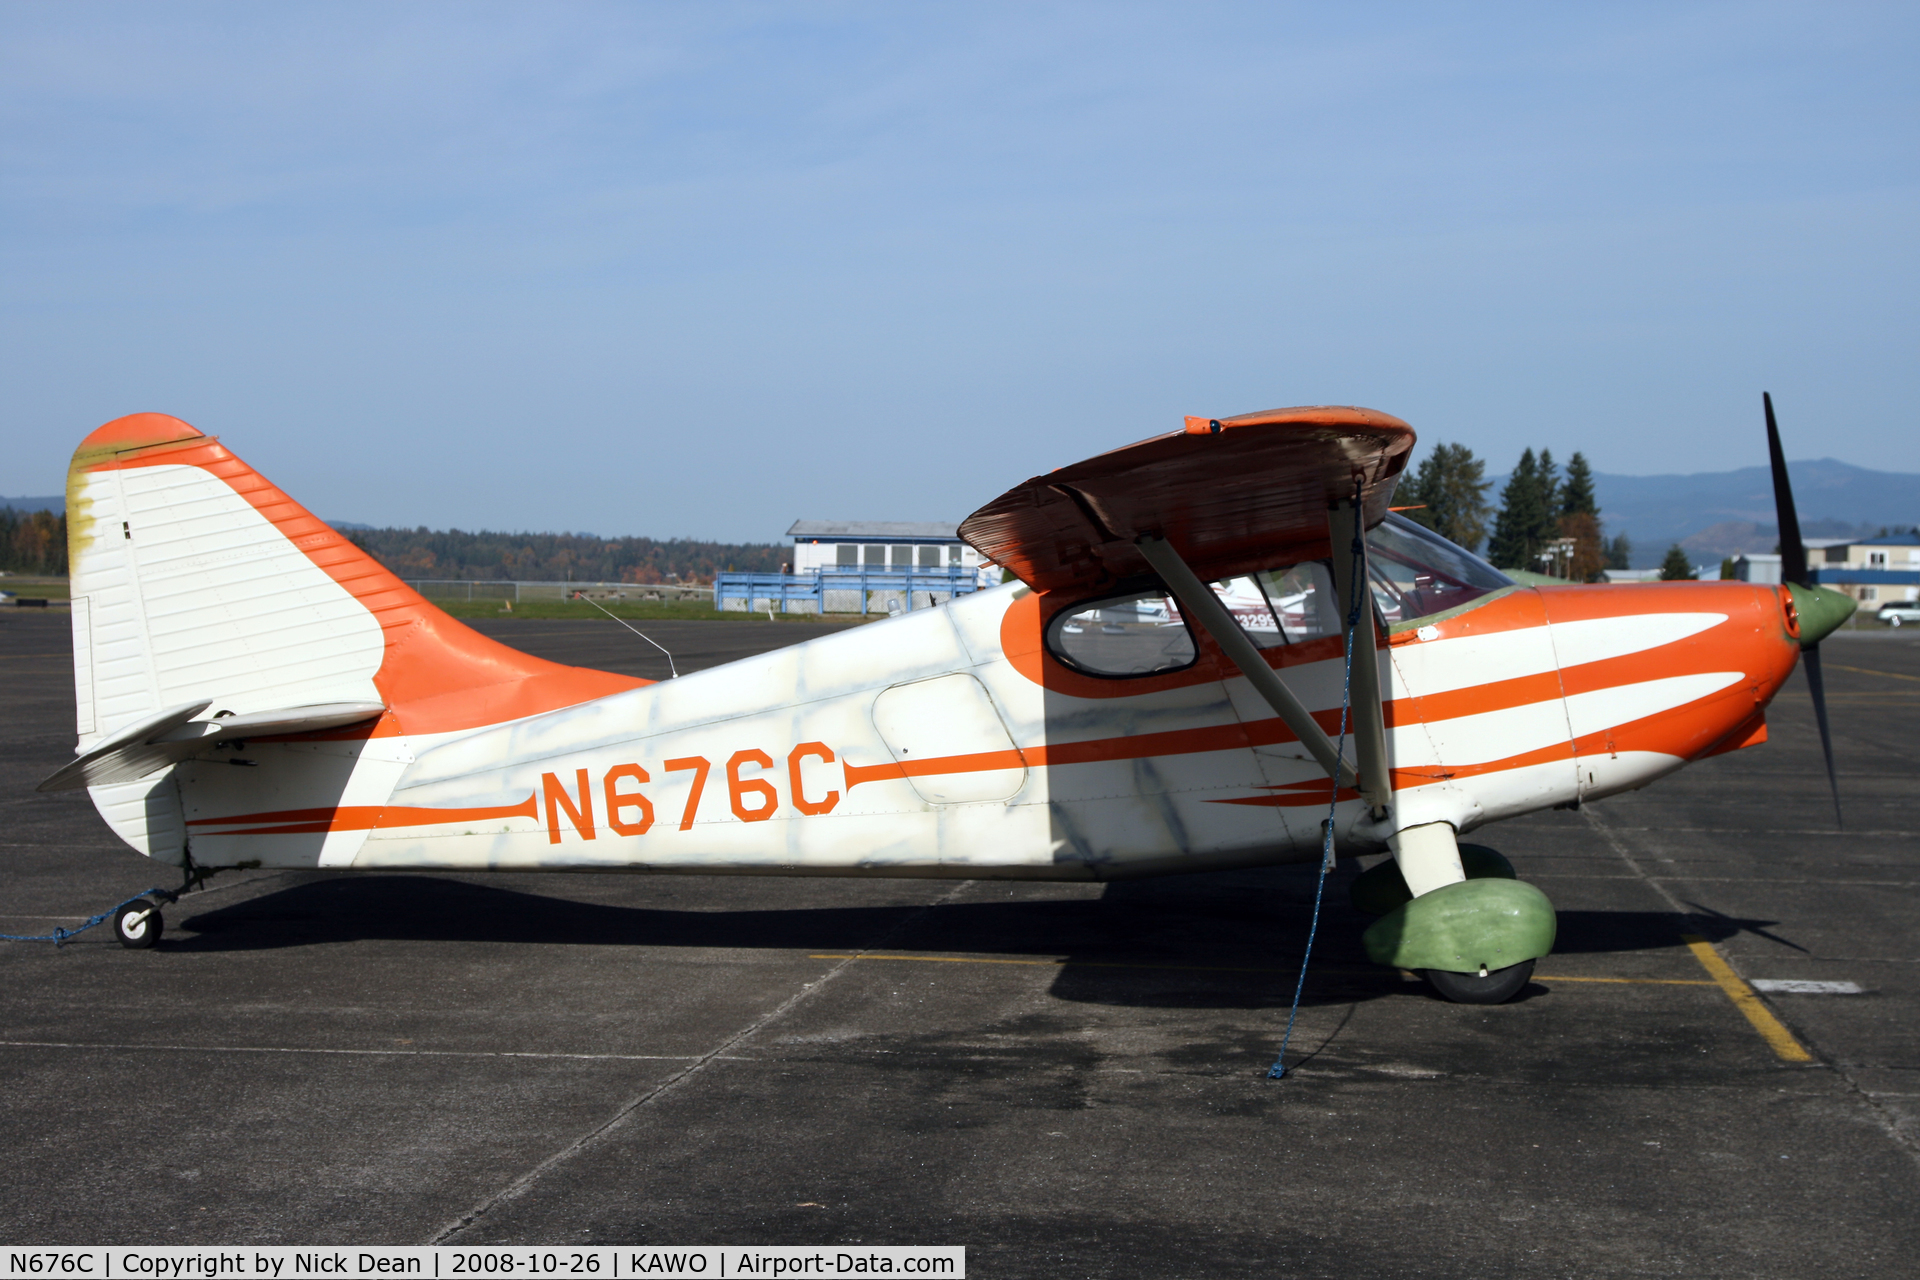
[{"left": 165, "top": 571, "right": 1797, "bottom": 879}]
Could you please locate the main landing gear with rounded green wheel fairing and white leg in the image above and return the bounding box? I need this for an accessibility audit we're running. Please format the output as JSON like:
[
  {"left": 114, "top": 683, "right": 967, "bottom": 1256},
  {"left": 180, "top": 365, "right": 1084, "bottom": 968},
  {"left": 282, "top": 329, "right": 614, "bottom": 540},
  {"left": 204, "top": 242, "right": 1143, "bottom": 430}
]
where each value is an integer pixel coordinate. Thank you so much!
[{"left": 1352, "top": 836, "right": 1555, "bottom": 1004}]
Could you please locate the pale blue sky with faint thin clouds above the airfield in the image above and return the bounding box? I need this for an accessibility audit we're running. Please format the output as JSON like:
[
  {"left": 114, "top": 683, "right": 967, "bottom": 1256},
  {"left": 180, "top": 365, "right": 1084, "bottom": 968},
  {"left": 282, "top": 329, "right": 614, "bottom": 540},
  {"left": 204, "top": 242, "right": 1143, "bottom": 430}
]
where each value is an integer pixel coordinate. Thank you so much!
[{"left": 0, "top": 2, "right": 1920, "bottom": 539}]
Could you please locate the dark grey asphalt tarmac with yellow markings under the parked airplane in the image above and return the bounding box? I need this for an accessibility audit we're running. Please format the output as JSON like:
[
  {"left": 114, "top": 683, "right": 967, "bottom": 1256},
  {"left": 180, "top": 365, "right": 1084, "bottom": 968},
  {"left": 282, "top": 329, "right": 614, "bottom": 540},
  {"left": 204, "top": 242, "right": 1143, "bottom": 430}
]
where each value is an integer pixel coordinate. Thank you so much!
[{"left": 0, "top": 610, "right": 1920, "bottom": 1278}]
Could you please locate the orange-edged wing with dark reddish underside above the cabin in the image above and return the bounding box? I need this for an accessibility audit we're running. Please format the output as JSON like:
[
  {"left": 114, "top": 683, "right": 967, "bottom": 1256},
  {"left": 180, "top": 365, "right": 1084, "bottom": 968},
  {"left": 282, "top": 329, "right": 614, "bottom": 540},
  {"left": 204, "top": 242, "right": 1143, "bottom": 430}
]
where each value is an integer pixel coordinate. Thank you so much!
[{"left": 960, "top": 405, "right": 1413, "bottom": 589}]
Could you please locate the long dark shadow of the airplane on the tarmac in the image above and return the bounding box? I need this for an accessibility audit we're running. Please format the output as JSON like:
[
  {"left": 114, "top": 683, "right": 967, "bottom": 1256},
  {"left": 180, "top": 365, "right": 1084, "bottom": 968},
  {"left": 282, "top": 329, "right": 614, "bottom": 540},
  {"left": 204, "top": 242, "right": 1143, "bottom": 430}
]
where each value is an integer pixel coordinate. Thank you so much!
[{"left": 161, "top": 865, "right": 1774, "bottom": 1009}]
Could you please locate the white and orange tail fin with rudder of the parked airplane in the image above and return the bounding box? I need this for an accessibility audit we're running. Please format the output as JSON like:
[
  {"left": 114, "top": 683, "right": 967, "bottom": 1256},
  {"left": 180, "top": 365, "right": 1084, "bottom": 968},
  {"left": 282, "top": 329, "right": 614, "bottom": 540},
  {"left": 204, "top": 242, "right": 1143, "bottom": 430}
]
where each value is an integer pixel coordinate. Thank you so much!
[{"left": 67, "top": 413, "right": 647, "bottom": 860}]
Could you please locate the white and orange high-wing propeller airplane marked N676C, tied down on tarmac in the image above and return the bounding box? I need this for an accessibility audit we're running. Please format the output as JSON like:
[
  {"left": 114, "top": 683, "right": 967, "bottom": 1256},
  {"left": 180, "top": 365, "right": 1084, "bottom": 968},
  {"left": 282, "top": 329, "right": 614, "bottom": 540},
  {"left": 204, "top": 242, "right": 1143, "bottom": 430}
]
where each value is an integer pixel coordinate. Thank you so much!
[{"left": 42, "top": 397, "right": 1853, "bottom": 1004}]
